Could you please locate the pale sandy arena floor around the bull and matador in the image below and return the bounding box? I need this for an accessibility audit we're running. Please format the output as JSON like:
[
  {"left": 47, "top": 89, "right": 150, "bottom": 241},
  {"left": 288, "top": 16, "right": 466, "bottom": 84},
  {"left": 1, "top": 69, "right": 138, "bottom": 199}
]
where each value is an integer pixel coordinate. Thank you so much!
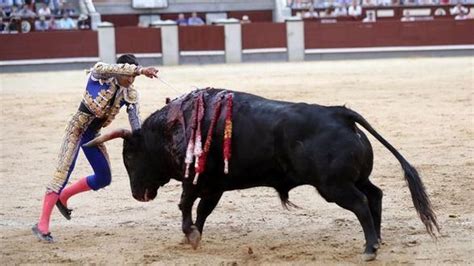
[{"left": 0, "top": 57, "right": 474, "bottom": 265}]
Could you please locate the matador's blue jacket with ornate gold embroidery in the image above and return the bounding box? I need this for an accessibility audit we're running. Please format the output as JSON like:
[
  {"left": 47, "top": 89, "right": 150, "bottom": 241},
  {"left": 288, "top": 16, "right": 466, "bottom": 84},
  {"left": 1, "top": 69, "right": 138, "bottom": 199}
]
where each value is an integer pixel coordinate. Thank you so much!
[{"left": 79, "top": 62, "right": 141, "bottom": 130}]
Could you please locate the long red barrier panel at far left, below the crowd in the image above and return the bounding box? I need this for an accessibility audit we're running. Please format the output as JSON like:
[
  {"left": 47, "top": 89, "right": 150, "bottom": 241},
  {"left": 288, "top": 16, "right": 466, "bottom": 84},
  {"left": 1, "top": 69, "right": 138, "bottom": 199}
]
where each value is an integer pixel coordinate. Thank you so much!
[{"left": 0, "top": 30, "right": 99, "bottom": 60}]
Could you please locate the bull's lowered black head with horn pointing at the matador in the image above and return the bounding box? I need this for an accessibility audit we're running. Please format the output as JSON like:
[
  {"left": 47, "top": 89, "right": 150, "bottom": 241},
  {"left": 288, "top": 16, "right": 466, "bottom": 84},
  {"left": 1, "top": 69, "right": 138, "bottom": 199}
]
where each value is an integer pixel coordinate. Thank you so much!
[{"left": 85, "top": 129, "right": 169, "bottom": 202}]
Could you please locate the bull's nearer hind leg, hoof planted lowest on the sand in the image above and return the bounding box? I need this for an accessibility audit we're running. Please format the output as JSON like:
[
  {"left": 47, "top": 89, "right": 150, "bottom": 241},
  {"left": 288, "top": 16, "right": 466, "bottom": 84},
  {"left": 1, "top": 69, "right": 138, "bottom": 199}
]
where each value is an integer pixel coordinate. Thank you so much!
[{"left": 319, "top": 185, "right": 379, "bottom": 261}]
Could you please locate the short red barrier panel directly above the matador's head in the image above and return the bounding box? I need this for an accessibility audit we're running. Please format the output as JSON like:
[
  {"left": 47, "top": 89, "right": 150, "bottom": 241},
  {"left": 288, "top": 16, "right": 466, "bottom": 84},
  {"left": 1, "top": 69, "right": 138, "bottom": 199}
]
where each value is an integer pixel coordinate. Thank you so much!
[{"left": 115, "top": 27, "right": 162, "bottom": 54}]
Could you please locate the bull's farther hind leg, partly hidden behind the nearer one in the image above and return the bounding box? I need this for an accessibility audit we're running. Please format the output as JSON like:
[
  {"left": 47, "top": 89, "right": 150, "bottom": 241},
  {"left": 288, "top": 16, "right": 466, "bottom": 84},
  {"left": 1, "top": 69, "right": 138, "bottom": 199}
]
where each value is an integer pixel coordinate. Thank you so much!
[{"left": 357, "top": 180, "right": 383, "bottom": 241}]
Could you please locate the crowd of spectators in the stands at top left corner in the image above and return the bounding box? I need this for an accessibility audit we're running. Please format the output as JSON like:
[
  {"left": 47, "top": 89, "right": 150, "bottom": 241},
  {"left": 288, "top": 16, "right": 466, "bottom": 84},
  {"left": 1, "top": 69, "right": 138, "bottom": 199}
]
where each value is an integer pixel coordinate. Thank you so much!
[{"left": 0, "top": 0, "right": 90, "bottom": 33}]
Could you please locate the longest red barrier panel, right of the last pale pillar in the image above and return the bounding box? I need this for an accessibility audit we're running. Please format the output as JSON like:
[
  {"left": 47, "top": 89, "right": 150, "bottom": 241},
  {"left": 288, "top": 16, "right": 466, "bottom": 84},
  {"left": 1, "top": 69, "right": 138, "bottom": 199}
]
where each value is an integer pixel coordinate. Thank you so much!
[{"left": 304, "top": 20, "right": 474, "bottom": 49}]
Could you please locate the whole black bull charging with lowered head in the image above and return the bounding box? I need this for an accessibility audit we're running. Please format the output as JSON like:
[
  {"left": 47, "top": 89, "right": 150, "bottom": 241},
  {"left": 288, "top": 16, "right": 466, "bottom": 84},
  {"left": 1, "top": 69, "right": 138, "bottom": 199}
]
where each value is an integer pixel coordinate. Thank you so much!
[{"left": 87, "top": 89, "right": 439, "bottom": 260}]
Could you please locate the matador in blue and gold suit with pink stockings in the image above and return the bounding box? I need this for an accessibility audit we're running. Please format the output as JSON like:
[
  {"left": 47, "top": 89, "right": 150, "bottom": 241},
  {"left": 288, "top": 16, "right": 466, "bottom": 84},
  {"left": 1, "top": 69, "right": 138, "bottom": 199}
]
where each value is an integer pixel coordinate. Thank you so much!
[{"left": 32, "top": 54, "right": 158, "bottom": 242}]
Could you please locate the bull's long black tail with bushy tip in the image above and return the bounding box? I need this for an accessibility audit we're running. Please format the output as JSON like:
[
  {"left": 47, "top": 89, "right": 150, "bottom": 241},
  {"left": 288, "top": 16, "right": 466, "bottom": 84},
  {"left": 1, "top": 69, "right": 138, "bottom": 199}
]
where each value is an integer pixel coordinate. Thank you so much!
[{"left": 343, "top": 107, "right": 440, "bottom": 238}]
